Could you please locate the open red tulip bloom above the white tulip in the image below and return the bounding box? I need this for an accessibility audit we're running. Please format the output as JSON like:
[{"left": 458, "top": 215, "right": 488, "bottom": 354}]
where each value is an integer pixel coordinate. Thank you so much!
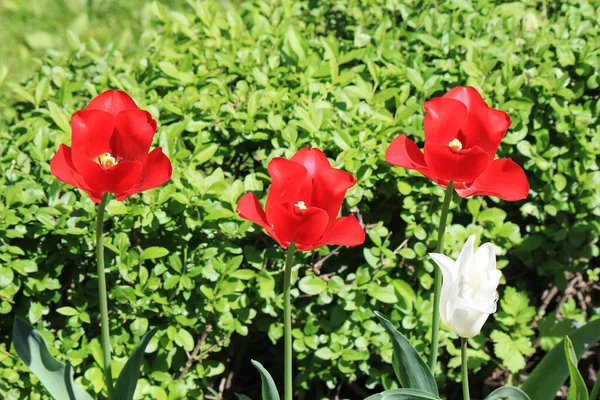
[{"left": 385, "top": 86, "right": 529, "bottom": 201}]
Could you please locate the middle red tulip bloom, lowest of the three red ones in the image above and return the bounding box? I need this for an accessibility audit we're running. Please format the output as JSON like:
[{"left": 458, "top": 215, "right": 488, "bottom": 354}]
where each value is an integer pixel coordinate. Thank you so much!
[{"left": 238, "top": 148, "right": 365, "bottom": 251}]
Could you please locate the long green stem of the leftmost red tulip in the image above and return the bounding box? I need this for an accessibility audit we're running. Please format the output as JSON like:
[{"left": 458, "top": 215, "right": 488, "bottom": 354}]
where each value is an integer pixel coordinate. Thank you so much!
[{"left": 96, "top": 193, "right": 113, "bottom": 400}]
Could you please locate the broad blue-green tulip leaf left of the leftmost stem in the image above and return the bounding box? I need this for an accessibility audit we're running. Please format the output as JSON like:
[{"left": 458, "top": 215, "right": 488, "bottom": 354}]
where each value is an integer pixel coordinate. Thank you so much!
[{"left": 13, "top": 318, "right": 92, "bottom": 400}]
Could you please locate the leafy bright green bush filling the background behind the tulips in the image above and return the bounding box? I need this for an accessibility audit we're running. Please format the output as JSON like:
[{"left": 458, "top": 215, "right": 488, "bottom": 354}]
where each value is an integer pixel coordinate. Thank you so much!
[{"left": 0, "top": 0, "right": 600, "bottom": 399}]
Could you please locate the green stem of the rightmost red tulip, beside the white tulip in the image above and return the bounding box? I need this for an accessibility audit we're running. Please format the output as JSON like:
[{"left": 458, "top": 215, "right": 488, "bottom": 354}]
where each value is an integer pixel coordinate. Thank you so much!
[{"left": 429, "top": 181, "right": 454, "bottom": 375}]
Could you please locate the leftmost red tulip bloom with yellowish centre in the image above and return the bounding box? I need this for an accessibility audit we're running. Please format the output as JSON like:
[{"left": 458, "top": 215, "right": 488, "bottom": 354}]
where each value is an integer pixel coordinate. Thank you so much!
[{"left": 50, "top": 90, "right": 172, "bottom": 203}]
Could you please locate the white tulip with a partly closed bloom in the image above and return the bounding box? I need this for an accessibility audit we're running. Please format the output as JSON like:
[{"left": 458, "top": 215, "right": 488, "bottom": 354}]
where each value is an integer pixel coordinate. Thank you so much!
[{"left": 430, "top": 235, "right": 502, "bottom": 338}]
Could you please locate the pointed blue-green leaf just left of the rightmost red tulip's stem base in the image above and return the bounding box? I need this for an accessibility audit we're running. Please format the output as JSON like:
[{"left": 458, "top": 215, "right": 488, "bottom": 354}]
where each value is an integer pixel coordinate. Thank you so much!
[{"left": 375, "top": 311, "right": 438, "bottom": 396}]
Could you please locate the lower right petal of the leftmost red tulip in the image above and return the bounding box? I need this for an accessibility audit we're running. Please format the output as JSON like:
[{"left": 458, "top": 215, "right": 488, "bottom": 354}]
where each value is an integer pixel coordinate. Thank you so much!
[{"left": 115, "top": 147, "right": 173, "bottom": 201}]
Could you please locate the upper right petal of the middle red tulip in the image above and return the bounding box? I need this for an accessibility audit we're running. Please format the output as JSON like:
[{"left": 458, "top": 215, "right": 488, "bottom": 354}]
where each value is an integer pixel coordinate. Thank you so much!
[{"left": 310, "top": 168, "right": 356, "bottom": 222}]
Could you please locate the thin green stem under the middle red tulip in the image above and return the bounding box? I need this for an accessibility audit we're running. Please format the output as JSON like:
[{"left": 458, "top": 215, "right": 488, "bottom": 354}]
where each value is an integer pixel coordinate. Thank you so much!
[{"left": 283, "top": 243, "right": 296, "bottom": 400}]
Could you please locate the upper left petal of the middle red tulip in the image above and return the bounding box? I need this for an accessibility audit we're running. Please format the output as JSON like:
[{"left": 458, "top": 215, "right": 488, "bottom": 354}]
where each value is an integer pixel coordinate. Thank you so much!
[{"left": 266, "top": 158, "right": 311, "bottom": 210}]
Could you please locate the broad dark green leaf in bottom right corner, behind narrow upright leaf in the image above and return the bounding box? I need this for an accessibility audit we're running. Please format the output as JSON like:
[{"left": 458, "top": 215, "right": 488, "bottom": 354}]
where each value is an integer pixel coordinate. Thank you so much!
[{"left": 521, "top": 319, "right": 600, "bottom": 400}]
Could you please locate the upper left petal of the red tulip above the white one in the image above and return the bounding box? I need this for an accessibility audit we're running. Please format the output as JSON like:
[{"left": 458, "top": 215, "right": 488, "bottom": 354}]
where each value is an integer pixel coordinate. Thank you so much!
[{"left": 423, "top": 98, "right": 468, "bottom": 147}]
